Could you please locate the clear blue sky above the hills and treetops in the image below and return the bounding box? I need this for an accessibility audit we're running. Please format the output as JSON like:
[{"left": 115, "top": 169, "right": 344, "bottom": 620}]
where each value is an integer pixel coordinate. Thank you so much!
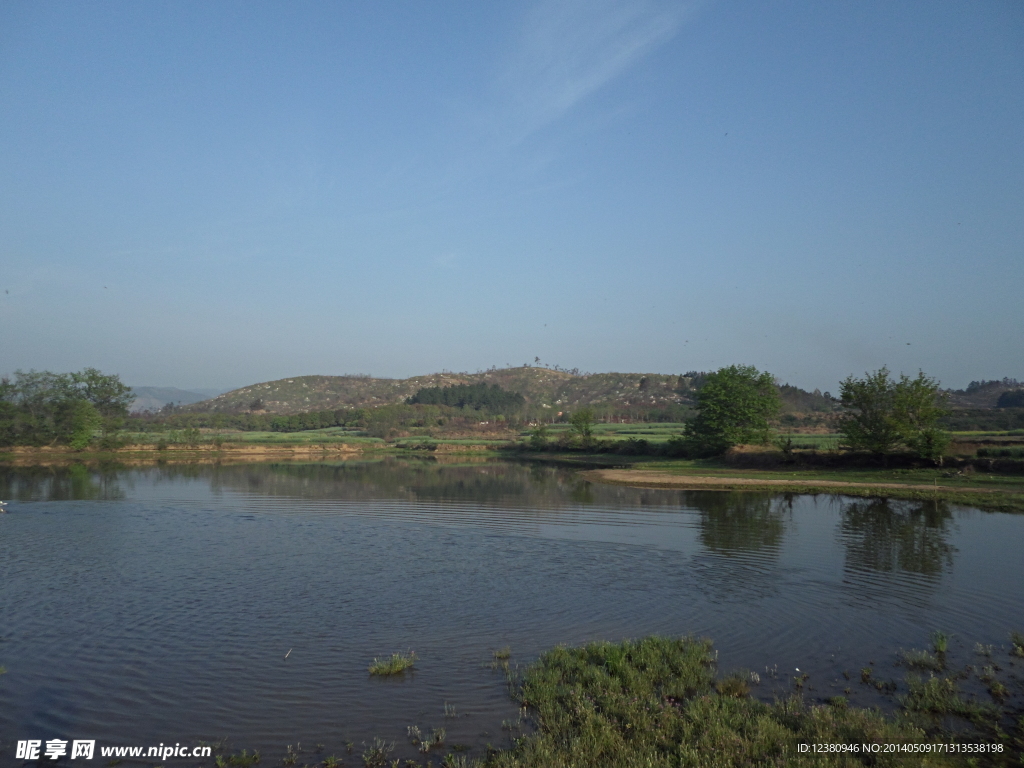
[{"left": 0, "top": 0, "right": 1024, "bottom": 392}]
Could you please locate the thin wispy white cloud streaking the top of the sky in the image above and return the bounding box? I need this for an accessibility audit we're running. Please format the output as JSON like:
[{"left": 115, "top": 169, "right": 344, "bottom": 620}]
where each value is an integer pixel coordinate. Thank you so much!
[{"left": 501, "top": 0, "right": 696, "bottom": 135}]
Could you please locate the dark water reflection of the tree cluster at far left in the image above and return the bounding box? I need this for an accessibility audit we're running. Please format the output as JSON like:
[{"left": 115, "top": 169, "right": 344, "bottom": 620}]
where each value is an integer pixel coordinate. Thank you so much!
[{"left": 0, "top": 464, "right": 125, "bottom": 502}]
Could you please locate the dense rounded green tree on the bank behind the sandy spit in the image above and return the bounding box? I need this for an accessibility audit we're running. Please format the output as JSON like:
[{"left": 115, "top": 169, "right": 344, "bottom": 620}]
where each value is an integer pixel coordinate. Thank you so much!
[{"left": 686, "top": 366, "right": 782, "bottom": 455}]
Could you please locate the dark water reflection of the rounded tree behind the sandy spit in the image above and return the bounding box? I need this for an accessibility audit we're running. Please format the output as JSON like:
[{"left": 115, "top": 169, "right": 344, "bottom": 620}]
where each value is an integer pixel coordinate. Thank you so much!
[{"left": 686, "top": 492, "right": 793, "bottom": 555}]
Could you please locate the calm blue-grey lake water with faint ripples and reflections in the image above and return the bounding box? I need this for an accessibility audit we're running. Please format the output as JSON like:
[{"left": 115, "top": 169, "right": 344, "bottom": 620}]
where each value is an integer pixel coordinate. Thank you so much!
[{"left": 0, "top": 461, "right": 1024, "bottom": 765}]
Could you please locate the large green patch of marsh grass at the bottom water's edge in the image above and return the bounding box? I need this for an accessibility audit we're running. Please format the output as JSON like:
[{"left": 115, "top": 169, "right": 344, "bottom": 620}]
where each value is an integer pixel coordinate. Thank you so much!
[{"left": 486, "top": 637, "right": 948, "bottom": 768}]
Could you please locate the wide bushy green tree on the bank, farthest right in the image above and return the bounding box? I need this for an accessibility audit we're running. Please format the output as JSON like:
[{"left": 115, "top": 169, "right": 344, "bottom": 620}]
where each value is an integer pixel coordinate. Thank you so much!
[{"left": 840, "top": 367, "right": 949, "bottom": 460}]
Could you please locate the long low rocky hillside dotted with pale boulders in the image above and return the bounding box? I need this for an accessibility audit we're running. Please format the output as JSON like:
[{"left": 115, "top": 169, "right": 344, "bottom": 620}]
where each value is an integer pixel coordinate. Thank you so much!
[{"left": 183, "top": 367, "right": 693, "bottom": 414}]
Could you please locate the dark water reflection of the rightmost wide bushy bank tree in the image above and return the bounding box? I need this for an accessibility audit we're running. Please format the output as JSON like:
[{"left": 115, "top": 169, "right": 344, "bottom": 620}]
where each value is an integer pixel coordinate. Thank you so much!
[{"left": 841, "top": 499, "right": 956, "bottom": 575}]
